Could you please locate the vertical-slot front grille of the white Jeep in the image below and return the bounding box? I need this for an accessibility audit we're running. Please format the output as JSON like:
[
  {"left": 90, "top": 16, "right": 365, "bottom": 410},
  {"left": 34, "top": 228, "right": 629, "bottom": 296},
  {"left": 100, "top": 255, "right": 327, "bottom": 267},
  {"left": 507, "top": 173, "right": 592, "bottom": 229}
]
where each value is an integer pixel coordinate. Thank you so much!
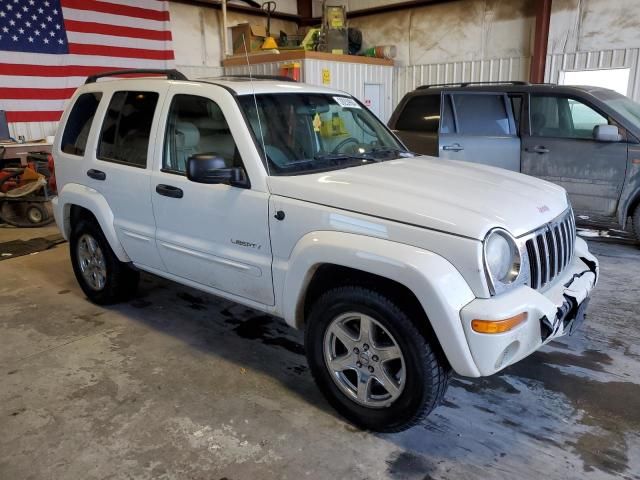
[{"left": 525, "top": 210, "right": 576, "bottom": 290}]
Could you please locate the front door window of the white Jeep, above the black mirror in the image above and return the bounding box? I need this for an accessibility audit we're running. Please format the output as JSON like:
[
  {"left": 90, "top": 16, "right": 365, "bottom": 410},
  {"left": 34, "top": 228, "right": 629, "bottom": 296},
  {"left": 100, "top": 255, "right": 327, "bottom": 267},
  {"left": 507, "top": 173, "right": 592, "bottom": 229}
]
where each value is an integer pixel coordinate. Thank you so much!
[{"left": 162, "top": 95, "right": 242, "bottom": 173}]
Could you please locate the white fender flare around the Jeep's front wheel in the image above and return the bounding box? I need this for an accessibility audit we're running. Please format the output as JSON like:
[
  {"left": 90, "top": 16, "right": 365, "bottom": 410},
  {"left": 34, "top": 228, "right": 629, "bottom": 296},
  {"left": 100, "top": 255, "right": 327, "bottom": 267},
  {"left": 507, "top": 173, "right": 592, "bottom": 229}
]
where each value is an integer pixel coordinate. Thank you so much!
[{"left": 282, "top": 232, "right": 478, "bottom": 376}]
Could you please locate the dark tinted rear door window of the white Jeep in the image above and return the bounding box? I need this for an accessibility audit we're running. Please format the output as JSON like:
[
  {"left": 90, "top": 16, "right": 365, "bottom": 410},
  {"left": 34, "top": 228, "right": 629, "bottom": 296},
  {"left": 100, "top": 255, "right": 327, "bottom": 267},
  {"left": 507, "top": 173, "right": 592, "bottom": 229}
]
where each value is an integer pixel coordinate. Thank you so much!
[{"left": 98, "top": 92, "right": 158, "bottom": 167}]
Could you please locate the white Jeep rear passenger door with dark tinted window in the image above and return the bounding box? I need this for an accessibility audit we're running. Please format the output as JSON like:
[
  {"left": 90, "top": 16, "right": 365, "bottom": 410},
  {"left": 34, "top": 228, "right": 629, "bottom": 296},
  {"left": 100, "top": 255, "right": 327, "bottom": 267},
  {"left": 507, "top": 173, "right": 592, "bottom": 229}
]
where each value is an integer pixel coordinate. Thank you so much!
[{"left": 92, "top": 85, "right": 166, "bottom": 269}]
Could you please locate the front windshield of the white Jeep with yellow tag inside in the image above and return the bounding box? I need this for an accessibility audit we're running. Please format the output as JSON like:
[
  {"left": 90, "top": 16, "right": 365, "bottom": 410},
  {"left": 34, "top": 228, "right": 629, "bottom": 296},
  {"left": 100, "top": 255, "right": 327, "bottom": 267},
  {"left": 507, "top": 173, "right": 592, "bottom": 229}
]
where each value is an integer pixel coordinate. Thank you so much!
[{"left": 239, "top": 93, "right": 412, "bottom": 175}]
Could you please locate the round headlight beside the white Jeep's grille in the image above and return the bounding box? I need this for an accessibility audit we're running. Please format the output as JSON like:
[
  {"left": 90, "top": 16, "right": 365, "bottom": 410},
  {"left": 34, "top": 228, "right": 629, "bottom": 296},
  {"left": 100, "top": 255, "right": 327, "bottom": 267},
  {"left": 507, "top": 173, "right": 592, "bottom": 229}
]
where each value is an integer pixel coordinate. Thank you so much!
[{"left": 484, "top": 229, "right": 521, "bottom": 294}]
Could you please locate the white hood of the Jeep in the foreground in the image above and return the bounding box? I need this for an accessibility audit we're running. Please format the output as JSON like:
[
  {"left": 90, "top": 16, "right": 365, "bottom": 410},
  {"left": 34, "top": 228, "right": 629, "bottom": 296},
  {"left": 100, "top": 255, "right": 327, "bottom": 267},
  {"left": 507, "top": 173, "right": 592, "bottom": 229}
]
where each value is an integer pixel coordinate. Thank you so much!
[{"left": 269, "top": 156, "right": 568, "bottom": 240}]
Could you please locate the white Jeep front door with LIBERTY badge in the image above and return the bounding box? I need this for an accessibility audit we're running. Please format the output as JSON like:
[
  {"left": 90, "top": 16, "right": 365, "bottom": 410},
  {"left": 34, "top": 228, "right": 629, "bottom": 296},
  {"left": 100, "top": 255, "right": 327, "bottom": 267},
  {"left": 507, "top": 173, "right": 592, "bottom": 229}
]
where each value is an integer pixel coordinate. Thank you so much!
[{"left": 151, "top": 85, "right": 274, "bottom": 305}]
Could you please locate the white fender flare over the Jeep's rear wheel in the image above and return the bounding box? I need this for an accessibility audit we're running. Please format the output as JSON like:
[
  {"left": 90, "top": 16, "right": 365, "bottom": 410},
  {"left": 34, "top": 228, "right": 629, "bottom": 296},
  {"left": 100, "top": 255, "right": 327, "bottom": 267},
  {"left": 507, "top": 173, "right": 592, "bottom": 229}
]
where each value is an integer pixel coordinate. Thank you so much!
[{"left": 53, "top": 183, "right": 131, "bottom": 262}]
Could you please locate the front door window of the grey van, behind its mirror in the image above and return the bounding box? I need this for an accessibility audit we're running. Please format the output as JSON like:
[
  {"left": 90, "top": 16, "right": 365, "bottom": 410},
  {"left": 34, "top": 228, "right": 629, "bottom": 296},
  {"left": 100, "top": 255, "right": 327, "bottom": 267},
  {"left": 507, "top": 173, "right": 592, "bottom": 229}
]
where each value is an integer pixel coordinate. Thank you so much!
[{"left": 530, "top": 96, "right": 609, "bottom": 139}]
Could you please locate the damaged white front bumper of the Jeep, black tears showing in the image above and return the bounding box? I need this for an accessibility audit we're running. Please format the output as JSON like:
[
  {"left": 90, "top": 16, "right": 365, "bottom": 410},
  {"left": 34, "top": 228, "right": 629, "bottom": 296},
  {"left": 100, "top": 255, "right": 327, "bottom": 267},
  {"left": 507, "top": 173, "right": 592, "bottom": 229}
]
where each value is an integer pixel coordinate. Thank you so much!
[{"left": 460, "top": 238, "right": 599, "bottom": 376}]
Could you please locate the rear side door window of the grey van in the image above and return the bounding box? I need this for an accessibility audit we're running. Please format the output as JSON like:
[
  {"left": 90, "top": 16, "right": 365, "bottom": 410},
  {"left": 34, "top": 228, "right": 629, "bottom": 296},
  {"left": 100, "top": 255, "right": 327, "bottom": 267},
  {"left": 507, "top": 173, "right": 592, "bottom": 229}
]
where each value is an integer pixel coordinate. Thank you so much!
[{"left": 453, "top": 94, "right": 511, "bottom": 136}]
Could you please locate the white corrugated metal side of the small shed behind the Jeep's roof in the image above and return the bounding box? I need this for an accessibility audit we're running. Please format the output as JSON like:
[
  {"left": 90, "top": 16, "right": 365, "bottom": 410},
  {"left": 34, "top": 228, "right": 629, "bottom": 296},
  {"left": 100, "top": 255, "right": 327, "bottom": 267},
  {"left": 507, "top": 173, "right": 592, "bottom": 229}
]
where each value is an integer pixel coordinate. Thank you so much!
[{"left": 225, "top": 59, "right": 395, "bottom": 122}]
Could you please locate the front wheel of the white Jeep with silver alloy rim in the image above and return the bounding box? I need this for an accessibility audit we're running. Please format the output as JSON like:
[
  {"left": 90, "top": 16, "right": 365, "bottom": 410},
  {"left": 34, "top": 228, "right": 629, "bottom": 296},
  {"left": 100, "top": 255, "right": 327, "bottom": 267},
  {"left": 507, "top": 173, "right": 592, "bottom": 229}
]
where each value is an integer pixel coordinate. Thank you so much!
[{"left": 305, "top": 286, "right": 451, "bottom": 432}]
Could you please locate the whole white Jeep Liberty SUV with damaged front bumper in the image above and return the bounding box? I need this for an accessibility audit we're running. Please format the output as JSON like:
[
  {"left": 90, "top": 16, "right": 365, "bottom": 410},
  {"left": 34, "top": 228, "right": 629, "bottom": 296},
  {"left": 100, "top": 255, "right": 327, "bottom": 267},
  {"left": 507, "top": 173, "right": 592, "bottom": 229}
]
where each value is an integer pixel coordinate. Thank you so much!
[{"left": 53, "top": 70, "right": 598, "bottom": 431}]
